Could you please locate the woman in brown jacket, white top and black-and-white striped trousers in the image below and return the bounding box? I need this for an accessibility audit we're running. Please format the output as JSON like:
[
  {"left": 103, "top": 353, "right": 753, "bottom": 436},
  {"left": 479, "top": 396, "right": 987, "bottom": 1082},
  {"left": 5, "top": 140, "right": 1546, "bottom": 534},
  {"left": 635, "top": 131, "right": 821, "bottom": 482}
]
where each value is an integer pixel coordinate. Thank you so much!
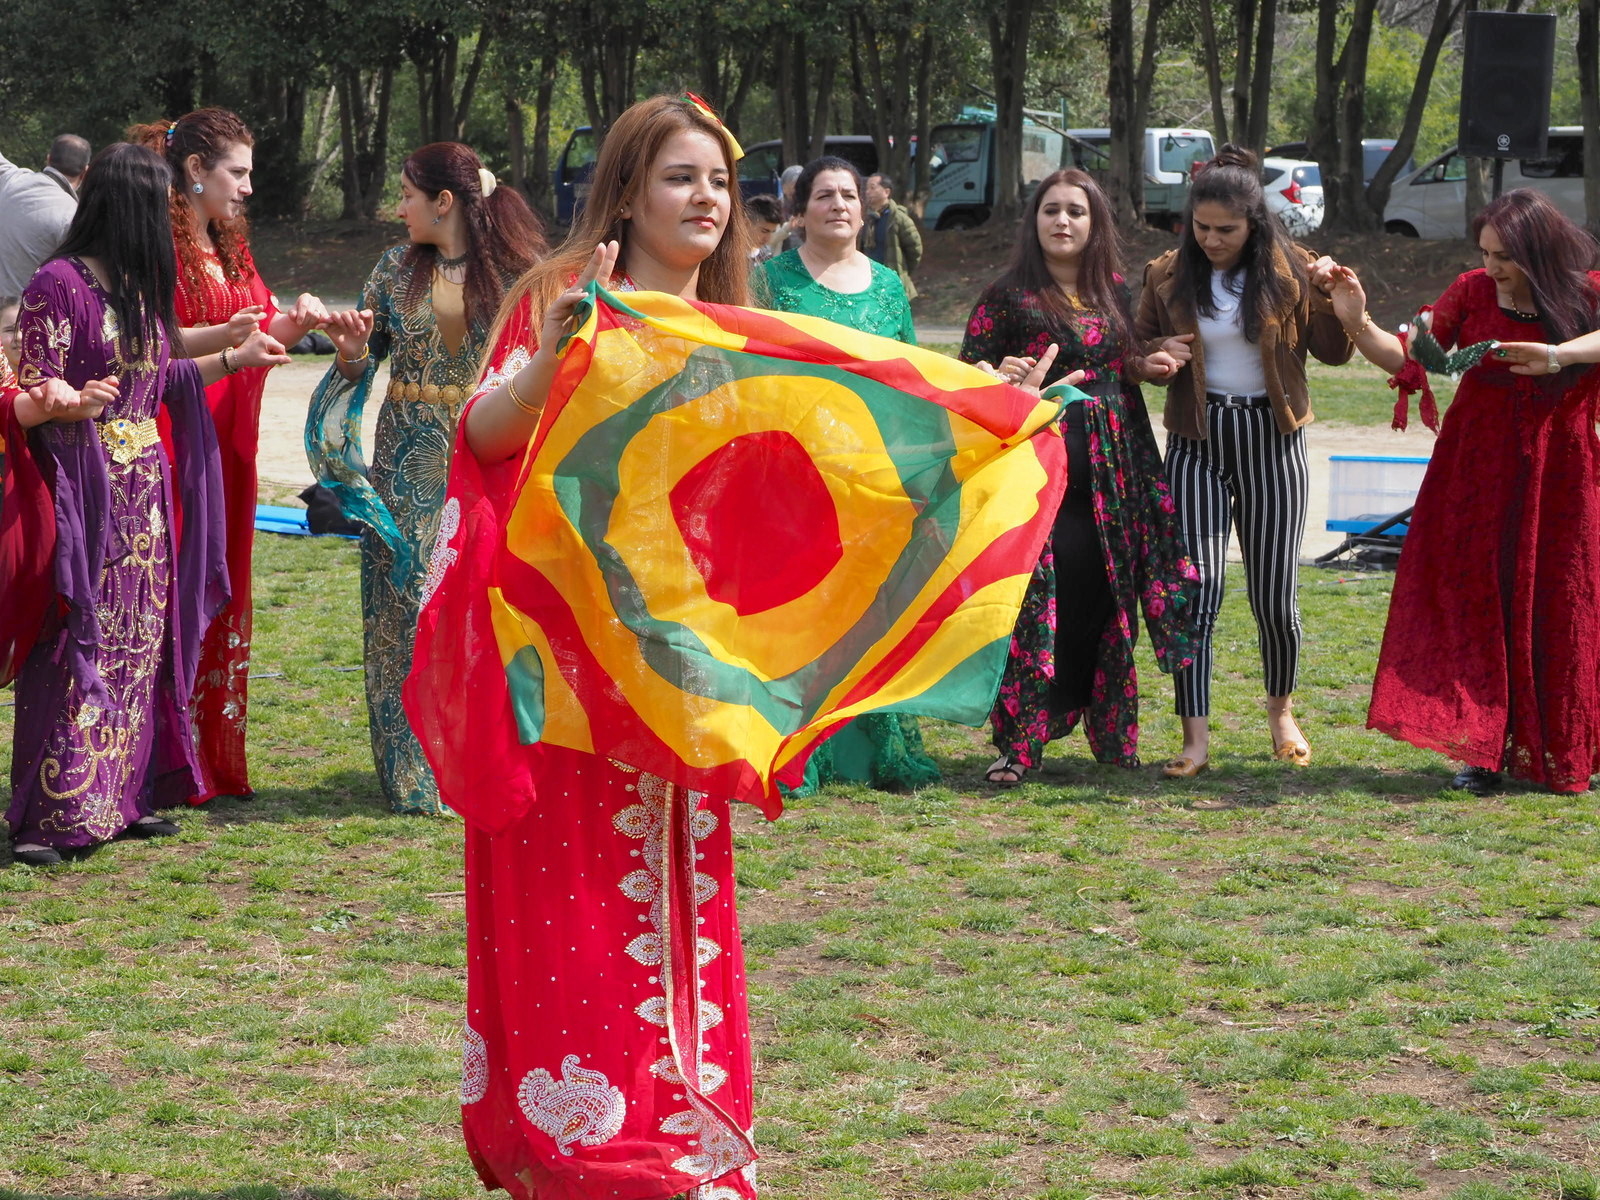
[{"left": 1134, "top": 146, "right": 1350, "bottom": 778}]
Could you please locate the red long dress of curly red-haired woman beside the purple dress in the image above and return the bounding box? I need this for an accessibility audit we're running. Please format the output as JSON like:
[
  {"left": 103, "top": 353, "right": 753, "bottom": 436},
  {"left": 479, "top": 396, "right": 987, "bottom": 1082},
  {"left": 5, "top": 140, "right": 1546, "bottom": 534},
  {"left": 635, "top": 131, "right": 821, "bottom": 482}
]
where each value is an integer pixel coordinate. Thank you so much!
[{"left": 163, "top": 250, "right": 277, "bottom": 805}]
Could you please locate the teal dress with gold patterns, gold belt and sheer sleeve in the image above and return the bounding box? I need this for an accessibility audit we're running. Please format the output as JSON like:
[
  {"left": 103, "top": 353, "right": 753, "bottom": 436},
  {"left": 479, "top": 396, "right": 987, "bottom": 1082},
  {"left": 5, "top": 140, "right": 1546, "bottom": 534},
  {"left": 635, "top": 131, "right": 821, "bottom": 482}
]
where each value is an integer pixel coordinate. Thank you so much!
[{"left": 306, "top": 246, "right": 488, "bottom": 813}]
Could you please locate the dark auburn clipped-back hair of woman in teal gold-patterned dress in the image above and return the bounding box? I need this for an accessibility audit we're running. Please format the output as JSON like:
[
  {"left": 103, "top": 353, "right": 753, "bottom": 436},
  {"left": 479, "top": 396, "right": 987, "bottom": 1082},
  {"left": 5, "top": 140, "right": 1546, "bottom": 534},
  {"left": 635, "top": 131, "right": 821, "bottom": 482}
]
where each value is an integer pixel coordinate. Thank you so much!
[{"left": 400, "top": 142, "right": 549, "bottom": 325}]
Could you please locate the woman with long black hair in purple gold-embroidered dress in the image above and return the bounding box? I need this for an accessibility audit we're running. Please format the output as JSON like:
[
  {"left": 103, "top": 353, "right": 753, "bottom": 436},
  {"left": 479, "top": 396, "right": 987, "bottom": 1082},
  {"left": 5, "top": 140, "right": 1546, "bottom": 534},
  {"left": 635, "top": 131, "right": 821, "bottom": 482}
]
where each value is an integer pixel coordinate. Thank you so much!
[{"left": 0, "top": 142, "right": 288, "bottom": 864}]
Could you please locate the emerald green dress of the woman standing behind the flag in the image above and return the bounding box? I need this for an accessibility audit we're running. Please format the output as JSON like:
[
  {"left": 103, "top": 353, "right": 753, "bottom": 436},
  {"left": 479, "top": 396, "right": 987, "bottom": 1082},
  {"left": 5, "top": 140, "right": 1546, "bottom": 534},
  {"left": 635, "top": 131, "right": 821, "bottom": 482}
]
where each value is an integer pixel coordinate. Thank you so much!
[{"left": 750, "top": 250, "right": 939, "bottom": 795}]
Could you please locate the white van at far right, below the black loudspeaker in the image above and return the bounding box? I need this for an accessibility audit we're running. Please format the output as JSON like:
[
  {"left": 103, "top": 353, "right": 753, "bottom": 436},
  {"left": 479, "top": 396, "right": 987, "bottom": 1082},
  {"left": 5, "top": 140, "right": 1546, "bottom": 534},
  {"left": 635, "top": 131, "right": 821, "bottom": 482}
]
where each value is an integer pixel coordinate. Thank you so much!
[{"left": 1384, "top": 125, "right": 1586, "bottom": 238}]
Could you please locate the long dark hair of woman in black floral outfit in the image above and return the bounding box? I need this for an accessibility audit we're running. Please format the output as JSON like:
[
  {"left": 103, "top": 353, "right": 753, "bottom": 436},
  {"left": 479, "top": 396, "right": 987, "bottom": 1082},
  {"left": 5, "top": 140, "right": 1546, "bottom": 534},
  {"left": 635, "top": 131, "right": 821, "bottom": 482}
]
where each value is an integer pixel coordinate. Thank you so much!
[{"left": 998, "top": 166, "right": 1133, "bottom": 354}]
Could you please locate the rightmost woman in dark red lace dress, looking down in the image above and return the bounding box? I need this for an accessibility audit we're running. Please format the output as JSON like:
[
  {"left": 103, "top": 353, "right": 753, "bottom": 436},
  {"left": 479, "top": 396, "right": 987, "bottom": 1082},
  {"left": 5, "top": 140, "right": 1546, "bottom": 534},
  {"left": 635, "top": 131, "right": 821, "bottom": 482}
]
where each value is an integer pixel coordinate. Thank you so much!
[{"left": 1328, "top": 189, "right": 1600, "bottom": 792}]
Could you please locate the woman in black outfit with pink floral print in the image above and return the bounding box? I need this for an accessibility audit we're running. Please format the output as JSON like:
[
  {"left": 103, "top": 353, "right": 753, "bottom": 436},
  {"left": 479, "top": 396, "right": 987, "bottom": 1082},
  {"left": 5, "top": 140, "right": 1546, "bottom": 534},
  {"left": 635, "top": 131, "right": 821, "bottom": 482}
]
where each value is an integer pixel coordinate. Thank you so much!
[{"left": 962, "top": 170, "right": 1198, "bottom": 787}]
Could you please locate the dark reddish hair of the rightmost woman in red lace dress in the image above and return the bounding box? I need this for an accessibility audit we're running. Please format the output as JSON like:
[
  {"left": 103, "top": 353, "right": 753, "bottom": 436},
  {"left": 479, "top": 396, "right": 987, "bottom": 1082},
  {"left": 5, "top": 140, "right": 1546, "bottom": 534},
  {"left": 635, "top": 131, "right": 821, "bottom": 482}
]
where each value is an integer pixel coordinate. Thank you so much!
[{"left": 1472, "top": 187, "right": 1600, "bottom": 342}]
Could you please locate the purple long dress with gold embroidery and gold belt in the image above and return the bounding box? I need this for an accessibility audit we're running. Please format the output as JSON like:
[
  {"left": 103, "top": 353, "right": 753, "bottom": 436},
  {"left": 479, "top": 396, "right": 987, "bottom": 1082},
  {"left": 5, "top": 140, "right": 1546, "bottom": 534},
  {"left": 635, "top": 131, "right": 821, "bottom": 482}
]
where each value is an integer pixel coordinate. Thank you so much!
[{"left": 6, "top": 259, "right": 227, "bottom": 848}]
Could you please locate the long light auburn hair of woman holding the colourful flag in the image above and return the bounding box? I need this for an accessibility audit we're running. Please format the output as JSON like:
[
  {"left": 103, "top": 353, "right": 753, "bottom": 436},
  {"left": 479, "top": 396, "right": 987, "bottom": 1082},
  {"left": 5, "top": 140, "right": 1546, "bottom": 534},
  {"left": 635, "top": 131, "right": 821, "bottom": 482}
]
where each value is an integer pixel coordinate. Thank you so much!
[{"left": 488, "top": 96, "right": 750, "bottom": 352}]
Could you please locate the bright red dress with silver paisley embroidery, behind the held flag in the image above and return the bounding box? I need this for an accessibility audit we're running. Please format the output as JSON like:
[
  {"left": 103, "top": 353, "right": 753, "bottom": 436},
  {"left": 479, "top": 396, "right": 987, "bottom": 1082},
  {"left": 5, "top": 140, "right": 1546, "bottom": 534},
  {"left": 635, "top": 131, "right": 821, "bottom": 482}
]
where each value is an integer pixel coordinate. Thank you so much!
[{"left": 406, "top": 298, "right": 755, "bottom": 1200}]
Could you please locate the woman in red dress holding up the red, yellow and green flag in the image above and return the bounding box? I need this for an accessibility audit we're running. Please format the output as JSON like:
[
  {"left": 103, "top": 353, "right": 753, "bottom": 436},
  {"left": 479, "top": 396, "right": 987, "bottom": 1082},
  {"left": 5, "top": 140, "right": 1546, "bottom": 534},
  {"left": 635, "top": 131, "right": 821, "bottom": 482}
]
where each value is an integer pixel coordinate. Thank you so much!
[{"left": 405, "top": 96, "right": 755, "bottom": 1200}]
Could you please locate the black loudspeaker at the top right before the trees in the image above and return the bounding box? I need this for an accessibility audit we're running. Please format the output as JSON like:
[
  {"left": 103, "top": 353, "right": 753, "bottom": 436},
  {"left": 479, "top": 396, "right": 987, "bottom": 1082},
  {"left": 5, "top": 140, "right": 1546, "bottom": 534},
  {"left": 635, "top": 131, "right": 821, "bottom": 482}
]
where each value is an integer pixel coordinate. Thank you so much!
[{"left": 1459, "top": 13, "right": 1555, "bottom": 158}]
